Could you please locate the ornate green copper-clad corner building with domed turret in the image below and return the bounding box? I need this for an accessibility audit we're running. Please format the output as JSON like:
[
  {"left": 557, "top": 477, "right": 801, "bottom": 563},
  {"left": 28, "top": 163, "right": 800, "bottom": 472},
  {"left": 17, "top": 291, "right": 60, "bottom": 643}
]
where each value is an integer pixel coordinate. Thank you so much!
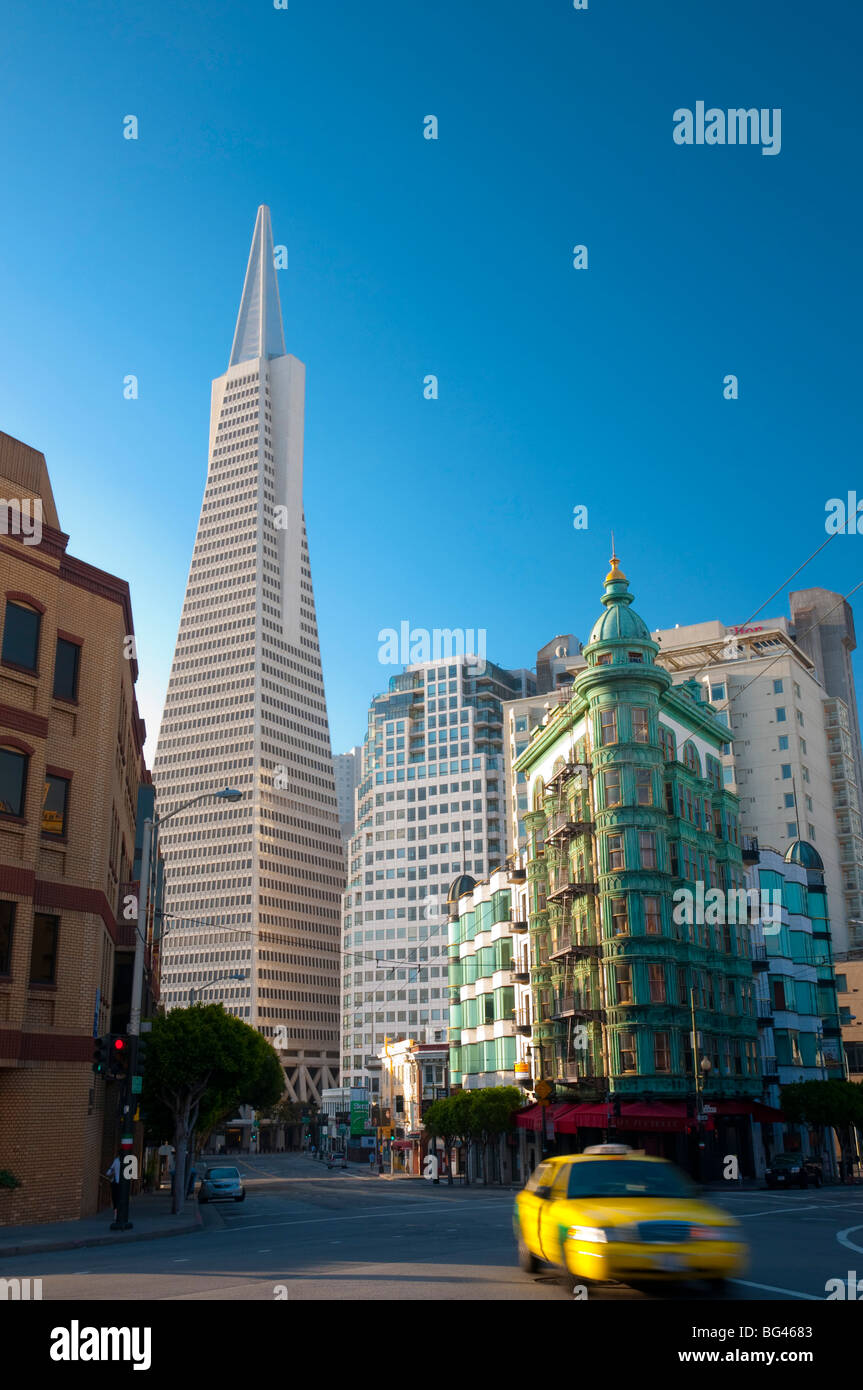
[{"left": 514, "top": 556, "right": 762, "bottom": 1170}]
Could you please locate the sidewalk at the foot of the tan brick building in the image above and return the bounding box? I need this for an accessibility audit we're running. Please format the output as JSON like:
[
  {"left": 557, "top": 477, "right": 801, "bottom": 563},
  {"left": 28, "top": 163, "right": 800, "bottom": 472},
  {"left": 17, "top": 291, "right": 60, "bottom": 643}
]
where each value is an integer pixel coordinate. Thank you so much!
[{"left": 0, "top": 1190, "right": 204, "bottom": 1259}]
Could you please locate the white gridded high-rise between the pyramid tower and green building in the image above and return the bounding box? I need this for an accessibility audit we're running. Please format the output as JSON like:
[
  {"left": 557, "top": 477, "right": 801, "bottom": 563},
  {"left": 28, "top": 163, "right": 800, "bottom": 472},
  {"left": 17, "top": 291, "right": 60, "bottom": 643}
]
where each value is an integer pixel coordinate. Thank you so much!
[{"left": 342, "top": 655, "right": 529, "bottom": 1090}]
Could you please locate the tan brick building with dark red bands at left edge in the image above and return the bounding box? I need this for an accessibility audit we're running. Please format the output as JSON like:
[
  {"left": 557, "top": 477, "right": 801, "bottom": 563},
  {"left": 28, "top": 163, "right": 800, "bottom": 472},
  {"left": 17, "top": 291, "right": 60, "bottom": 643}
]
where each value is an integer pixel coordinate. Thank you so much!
[{"left": 0, "top": 434, "right": 149, "bottom": 1225}]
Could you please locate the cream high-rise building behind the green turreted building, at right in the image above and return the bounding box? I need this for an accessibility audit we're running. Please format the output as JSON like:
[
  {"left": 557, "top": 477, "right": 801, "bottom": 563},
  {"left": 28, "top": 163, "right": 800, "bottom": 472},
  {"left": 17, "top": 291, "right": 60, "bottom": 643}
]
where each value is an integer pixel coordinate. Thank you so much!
[{"left": 653, "top": 617, "right": 863, "bottom": 951}]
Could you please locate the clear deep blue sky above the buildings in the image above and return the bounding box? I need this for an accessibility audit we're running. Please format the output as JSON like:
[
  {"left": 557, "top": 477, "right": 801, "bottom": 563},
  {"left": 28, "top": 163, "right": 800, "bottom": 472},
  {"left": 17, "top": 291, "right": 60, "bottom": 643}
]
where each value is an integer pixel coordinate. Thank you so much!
[{"left": 0, "top": 0, "right": 863, "bottom": 758}]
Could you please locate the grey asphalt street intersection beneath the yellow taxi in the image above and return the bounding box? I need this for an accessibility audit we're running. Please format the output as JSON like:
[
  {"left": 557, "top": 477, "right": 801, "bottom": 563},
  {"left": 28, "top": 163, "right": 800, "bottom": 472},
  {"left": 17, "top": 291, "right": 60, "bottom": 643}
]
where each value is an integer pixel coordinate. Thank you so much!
[{"left": 16, "top": 1155, "right": 863, "bottom": 1301}]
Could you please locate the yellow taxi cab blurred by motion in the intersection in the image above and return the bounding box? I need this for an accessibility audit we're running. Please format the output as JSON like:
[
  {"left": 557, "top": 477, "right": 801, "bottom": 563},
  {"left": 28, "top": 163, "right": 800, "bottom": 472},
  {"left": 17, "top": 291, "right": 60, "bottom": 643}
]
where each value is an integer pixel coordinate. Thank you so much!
[{"left": 514, "top": 1144, "right": 748, "bottom": 1293}]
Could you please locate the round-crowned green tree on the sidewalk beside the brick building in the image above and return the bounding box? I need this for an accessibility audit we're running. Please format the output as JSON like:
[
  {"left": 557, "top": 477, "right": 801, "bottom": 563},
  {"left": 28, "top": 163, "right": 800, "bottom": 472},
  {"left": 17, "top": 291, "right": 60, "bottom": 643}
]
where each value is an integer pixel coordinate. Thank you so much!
[{"left": 142, "top": 1004, "right": 285, "bottom": 1212}]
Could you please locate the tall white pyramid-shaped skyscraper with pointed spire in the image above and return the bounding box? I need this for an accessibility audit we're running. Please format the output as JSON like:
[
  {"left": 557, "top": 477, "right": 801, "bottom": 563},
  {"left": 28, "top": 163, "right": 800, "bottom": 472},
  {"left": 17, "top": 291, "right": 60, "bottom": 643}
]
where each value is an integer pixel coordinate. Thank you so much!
[{"left": 153, "top": 207, "right": 345, "bottom": 1101}]
